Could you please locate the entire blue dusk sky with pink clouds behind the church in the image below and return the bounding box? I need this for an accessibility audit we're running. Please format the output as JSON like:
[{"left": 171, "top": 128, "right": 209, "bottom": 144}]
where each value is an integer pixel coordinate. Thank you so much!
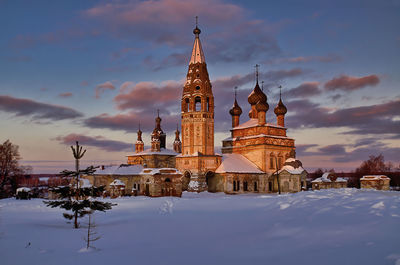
[{"left": 0, "top": 0, "right": 400, "bottom": 173}]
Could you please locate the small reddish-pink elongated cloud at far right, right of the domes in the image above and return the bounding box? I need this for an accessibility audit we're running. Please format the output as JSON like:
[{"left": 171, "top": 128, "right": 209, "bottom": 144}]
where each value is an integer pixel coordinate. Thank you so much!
[{"left": 325, "top": 75, "right": 380, "bottom": 91}]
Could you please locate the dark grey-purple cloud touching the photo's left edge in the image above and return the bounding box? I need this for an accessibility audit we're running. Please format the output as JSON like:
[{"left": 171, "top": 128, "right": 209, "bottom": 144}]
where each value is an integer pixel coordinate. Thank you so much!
[{"left": 0, "top": 95, "right": 83, "bottom": 121}]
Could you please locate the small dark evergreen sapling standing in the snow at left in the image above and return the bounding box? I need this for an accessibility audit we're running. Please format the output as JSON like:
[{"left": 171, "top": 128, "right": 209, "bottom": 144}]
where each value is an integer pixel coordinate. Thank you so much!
[{"left": 44, "top": 142, "right": 115, "bottom": 228}]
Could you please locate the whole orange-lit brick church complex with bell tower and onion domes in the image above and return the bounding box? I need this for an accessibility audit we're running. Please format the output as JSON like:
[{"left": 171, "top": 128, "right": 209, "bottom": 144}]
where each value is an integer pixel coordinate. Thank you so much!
[{"left": 83, "top": 21, "right": 307, "bottom": 196}]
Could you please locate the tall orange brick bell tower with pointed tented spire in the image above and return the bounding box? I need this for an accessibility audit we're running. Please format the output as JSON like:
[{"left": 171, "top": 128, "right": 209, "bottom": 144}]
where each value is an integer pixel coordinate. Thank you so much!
[{"left": 176, "top": 17, "right": 221, "bottom": 191}]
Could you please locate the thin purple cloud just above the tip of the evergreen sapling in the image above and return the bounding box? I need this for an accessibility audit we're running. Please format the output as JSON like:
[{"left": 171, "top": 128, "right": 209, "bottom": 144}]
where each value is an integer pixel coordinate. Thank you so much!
[{"left": 55, "top": 133, "right": 133, "bottom": 152}]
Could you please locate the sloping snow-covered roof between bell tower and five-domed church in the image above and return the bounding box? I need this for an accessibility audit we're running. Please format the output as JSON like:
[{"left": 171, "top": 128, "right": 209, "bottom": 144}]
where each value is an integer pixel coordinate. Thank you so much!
[{"left": 215, "top": 154, "right": 264, "bottom": 174}]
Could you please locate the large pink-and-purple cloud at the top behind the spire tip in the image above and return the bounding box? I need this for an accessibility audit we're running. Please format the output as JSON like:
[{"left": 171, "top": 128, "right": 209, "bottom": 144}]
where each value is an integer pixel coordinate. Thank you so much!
[{"left": 82, "top": 0, "right": 282, "bottom": 66}]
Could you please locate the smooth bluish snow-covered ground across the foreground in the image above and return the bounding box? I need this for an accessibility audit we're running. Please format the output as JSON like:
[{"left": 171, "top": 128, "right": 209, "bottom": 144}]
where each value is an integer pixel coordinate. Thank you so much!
[{"left": 0, "top": 189, "right": 400, "bottom": 265}]
